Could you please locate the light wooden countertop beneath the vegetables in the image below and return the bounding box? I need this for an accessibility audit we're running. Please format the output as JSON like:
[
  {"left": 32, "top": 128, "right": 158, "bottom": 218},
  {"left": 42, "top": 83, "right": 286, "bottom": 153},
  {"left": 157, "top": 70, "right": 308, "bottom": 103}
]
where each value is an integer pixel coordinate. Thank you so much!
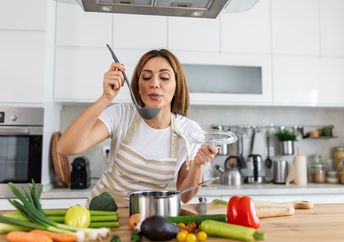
[{"left": 0, "top": 204, "right": 344, "bottom": 242}]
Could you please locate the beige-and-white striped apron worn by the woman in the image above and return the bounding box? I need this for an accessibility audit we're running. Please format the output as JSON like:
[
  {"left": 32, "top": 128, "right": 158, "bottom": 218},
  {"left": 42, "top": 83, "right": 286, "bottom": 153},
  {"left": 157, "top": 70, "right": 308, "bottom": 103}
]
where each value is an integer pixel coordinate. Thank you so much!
[{"left": 88, "top": 112, "right": 190, "bottom": 207}]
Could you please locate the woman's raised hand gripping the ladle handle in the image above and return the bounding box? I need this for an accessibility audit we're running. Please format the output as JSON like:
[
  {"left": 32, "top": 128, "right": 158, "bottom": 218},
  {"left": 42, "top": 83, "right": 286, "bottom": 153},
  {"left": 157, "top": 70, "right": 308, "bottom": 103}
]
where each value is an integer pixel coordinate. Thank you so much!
[{"left": 103, "top": 63, "right": 124, "bottom": 100}]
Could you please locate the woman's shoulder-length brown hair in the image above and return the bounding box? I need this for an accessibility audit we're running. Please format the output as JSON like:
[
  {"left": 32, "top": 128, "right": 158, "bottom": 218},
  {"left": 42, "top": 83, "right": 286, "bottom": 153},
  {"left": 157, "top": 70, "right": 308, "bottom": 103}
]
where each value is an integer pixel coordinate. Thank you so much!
[{"left": 131, "top": 49, "right": 189, "bottom": 116}]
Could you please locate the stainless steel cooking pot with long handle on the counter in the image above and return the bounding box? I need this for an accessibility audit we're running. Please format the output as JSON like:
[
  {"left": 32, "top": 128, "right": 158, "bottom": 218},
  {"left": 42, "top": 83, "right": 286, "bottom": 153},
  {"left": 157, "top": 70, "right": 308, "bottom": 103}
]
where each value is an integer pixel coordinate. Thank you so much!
[{"left": 128, "top": 177, "right": 219, "bottom": 218}]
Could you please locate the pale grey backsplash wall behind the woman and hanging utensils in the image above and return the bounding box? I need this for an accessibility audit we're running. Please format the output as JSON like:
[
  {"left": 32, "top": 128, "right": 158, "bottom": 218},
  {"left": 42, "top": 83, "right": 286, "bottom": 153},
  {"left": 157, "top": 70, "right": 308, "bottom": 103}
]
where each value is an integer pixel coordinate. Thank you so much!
[{"left": 61, "top": 105, "right": 344, "bottom": 177}]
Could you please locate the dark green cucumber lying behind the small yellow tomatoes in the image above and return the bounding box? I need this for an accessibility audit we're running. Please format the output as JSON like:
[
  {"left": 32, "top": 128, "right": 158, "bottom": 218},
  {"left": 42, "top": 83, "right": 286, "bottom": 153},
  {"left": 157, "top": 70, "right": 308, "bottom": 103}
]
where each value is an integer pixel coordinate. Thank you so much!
[{"left": 166, "top": 214, "right": 227, "bottom": 225}]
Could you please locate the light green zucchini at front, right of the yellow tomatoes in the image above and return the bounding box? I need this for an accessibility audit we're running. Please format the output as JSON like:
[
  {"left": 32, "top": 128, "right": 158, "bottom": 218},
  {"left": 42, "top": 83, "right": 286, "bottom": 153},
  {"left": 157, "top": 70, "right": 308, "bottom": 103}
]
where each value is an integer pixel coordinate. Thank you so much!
[{"left": 200, "top": 220, "right": 265, "bottom": 242}]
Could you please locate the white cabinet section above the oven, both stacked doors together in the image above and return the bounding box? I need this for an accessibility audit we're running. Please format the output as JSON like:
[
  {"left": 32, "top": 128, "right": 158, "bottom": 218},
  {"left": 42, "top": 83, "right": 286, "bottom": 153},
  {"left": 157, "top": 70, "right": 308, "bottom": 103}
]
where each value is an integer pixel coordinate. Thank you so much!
[{"left": 0, "top": 0, "right": 47, "bottom": 105}]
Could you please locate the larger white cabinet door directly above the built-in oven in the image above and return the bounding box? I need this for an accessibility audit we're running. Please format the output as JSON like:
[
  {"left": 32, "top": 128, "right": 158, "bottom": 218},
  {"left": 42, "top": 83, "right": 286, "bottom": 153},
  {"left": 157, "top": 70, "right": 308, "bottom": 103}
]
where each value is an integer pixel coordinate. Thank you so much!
[{"left": 0, "top": 31, "right": 46, "bottom": 104}]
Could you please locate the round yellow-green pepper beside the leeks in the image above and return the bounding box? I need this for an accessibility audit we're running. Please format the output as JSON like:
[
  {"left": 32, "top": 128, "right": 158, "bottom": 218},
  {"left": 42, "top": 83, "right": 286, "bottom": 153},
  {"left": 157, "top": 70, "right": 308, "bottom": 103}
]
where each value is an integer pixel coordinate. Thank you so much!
[{"left": 64, "top": 205, "right": 91, "bottom": 228}]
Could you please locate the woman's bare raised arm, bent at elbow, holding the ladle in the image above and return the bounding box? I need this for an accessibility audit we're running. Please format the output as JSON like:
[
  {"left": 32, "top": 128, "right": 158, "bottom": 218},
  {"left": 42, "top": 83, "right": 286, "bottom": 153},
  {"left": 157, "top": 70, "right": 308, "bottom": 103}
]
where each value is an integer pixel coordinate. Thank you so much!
[{"left": 57, "top": 63, "right": 124, "bottom": 155}]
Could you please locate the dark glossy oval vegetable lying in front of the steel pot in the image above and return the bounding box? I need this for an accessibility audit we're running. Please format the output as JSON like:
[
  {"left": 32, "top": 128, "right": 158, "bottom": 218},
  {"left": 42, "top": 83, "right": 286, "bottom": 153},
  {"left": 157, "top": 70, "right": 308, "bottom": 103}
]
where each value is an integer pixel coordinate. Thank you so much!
[{"left": 141, "top": 215, "right": 180, "bottom": 241}]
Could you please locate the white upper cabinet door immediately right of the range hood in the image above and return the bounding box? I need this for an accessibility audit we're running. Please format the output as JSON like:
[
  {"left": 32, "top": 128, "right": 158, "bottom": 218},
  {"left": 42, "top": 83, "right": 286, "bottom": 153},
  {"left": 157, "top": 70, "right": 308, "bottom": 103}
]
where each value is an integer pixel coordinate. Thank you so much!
[{"left": 220, "top": 0, "right": 271, "bottom": 54}]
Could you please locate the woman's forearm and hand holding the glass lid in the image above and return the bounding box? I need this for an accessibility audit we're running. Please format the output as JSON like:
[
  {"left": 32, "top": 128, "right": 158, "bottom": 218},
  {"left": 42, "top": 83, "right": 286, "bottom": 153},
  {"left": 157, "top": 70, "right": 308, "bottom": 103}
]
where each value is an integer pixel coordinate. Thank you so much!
[{"left": 177, "top": 146, "right": 218, "bottom": 203}]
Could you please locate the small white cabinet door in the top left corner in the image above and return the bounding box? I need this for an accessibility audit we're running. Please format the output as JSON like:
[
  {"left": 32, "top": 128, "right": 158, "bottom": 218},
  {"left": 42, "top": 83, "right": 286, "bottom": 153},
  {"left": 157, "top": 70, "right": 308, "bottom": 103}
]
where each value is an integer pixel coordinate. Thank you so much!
[{"left": 0, "top": 0, "right": 47, "bottom": 31}]
